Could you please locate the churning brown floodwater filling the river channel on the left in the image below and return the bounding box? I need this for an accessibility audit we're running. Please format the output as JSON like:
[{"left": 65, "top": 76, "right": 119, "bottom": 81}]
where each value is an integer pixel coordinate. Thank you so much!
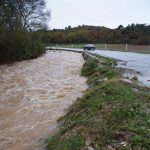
[{"left": 0, "top": 51, "right": 87, "bottom": 150}]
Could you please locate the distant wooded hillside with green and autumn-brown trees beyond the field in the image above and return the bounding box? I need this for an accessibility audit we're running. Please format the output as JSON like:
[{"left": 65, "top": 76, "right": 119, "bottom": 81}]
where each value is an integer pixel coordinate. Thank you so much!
[{"left": 40, "top": 24, "right": 150, "bottom": 45}]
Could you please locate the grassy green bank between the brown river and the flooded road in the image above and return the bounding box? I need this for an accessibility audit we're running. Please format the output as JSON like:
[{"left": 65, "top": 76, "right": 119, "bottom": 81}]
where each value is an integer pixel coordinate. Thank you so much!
[{"left": 47, "top": 52, "right": 150, "bottom": 150}]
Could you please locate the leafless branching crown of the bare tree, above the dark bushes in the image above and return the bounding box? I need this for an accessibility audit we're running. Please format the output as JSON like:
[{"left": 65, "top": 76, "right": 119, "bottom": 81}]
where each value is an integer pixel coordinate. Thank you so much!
[{"left": 0, "top": 0, "right": 50, "bottom": 30}]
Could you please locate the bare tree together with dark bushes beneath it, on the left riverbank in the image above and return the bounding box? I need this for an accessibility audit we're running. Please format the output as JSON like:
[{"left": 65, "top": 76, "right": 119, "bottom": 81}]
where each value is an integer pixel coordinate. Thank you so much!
[{"left": 0, "top": 0, "right": 49, "bottom": 63}]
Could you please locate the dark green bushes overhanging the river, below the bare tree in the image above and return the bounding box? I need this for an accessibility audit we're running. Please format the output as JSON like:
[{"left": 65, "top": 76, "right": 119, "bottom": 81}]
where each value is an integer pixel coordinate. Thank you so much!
[{"left": 0, "top": 31, "right": 45, "bottom": 63}]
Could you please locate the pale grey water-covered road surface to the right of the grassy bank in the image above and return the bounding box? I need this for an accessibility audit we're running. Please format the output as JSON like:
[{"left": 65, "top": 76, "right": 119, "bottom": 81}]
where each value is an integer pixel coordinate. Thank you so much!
[{"left": 90, "top": 50, "right": 150, "bottom": 87}]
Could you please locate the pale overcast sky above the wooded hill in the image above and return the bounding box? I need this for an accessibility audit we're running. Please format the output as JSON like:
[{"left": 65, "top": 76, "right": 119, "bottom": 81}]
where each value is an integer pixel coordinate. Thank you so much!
[{"left": 46, "top": 0, "right": 150, "bottom": 28}]
